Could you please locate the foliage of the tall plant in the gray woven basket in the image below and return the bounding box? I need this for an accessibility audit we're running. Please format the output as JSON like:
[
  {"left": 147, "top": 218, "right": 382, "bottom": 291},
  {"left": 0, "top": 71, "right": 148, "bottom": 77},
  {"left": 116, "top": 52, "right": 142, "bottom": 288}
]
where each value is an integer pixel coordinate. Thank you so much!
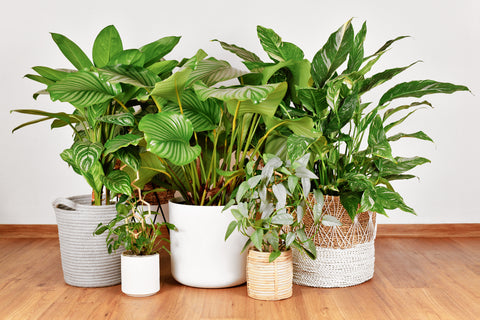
[{"left": 13, "top": 26, "right": 179, "bottom": 205}]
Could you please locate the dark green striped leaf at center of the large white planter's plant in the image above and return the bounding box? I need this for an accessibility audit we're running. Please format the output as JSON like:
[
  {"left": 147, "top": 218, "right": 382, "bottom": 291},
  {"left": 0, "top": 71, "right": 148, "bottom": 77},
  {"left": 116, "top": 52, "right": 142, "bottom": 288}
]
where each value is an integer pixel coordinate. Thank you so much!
[{"left": 164, "top": 90, "right": 222, "bottom": 132}]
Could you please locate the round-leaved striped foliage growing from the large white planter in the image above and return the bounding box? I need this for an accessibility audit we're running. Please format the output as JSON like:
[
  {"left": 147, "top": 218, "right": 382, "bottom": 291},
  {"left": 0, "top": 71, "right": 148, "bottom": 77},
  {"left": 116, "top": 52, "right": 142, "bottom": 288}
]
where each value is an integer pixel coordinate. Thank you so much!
[{"left": 139, "top": 50, "right": 286, "bottom": 205}]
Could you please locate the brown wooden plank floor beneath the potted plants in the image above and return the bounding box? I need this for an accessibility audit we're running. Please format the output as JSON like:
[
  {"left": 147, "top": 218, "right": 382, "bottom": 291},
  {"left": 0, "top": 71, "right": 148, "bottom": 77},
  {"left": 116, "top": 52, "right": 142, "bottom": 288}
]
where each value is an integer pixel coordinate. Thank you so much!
[{"left": 0, "top": 237, "right": 480, "bottom": 320}]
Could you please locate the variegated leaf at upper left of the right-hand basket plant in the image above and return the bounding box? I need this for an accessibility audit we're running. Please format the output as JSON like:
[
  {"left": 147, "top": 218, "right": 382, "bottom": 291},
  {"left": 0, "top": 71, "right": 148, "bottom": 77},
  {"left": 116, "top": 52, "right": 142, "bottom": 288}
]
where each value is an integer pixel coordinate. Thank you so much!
[{"left": 257, "top": 26, "right": 304, "bottom": 61}]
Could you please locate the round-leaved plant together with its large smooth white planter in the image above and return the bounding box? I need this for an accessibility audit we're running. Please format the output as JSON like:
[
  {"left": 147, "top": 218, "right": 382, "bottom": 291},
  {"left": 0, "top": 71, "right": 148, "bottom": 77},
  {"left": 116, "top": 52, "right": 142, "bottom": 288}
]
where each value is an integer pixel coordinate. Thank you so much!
[{"left": 139, "top": 50, "right": 286, "bottom": 288}]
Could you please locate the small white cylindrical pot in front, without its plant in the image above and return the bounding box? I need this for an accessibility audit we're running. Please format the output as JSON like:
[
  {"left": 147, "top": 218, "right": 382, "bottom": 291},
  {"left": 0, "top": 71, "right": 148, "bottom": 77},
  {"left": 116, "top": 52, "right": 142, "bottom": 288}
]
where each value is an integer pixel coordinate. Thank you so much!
[{"left": 122, "top": 253, "right": 160, "bottom": 297}]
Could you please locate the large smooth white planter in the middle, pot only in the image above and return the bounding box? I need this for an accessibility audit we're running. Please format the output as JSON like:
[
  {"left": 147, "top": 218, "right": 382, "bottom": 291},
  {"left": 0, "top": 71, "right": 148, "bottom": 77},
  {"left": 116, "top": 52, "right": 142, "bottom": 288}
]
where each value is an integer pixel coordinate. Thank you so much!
[{"left": 169, "top": 198, "right": 247, "bottom": 288}]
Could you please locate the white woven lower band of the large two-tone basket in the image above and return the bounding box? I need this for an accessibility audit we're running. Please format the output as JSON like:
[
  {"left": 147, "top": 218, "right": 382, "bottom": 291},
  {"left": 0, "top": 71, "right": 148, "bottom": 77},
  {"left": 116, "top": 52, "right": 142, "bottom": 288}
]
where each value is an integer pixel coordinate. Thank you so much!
[{"left": 293, "top": 241, "right": 375, "bottom": 288}]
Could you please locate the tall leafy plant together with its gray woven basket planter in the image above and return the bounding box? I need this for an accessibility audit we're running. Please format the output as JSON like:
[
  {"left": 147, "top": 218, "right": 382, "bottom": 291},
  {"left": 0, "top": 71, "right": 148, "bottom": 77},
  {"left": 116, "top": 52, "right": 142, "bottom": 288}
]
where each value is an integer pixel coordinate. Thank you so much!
[{"left": 13, "top": 26, "right": 179, "bottom": 287}]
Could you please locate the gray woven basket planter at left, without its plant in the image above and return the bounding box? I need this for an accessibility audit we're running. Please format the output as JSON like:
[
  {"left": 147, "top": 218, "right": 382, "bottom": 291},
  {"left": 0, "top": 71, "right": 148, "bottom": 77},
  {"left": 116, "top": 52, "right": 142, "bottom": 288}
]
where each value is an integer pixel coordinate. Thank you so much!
[{"left": 53, "top": 195, "right": 121, "bottom": 287}]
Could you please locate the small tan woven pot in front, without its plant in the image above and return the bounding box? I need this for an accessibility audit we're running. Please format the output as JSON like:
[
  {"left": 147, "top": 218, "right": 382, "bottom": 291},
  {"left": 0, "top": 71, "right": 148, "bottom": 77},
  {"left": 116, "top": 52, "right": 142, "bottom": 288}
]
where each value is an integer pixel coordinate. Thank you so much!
[{"left": 247, "top": 249, "right": 293, "bottom": 300}]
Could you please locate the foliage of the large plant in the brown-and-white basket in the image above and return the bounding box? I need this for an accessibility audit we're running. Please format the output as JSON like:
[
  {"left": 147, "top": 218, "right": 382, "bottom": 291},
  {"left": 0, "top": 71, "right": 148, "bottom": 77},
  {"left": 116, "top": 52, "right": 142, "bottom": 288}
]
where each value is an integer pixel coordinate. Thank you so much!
[{"left": 217, "top": 21, "right": 468, "bottom": 219}]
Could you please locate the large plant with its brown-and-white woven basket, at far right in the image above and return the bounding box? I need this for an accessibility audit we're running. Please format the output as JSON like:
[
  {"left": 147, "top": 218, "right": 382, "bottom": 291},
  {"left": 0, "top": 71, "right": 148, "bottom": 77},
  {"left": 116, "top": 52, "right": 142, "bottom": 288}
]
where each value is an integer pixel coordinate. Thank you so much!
[{"left": 216, "top": 21, "right": 468, "bottom": 287}]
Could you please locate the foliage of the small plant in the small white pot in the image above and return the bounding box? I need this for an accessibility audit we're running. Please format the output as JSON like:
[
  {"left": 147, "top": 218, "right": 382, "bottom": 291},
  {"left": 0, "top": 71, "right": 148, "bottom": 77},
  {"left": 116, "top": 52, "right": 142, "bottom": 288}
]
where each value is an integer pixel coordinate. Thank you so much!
[{"left": 94, "top": 176, "right": 175, "bottom": 255}]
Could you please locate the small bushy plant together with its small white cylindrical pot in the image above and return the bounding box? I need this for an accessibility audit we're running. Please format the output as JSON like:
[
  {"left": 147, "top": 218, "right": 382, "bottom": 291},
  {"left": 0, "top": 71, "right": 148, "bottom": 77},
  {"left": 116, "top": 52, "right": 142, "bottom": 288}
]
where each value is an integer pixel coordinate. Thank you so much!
[{"left": 95, "top": 175, "right": 175, "bottom": 297}]
